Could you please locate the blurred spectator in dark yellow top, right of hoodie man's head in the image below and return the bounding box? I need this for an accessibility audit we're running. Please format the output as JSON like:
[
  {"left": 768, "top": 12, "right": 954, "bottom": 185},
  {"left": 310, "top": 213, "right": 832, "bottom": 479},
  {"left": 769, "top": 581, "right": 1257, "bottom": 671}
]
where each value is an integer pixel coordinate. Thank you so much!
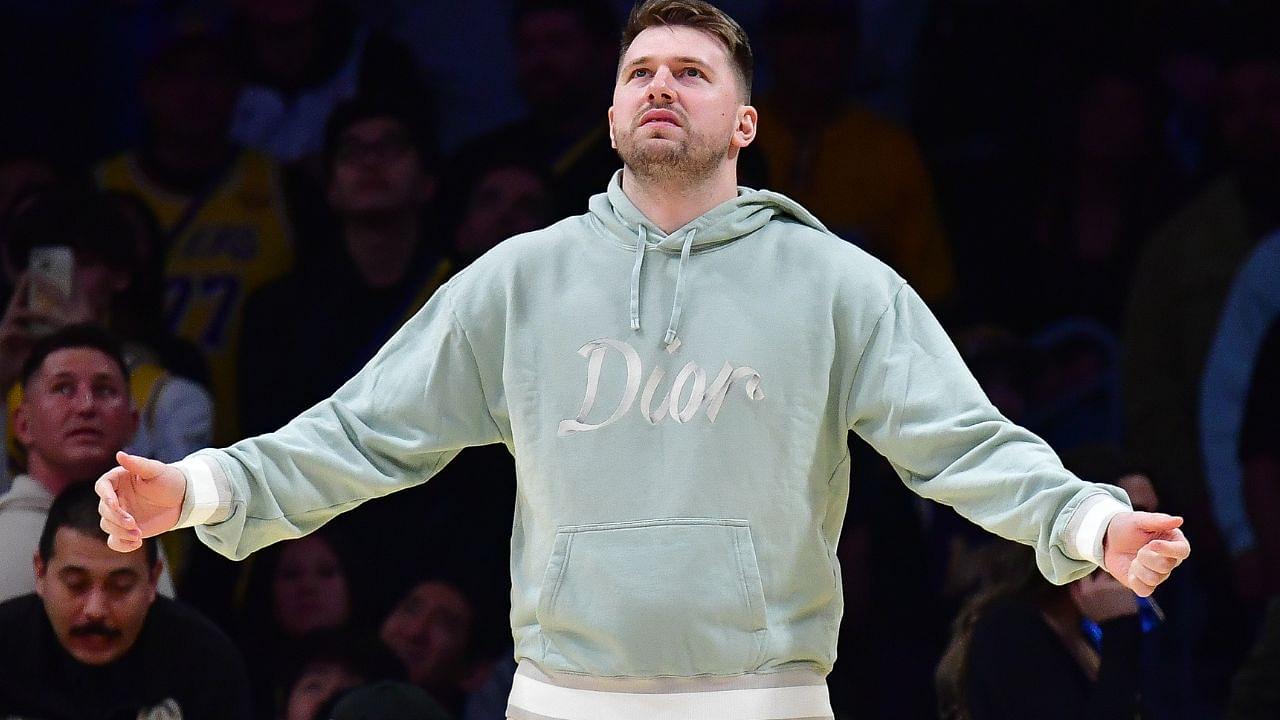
[{"left": 744, "top": 0, "right": 955, "bottom": 304}]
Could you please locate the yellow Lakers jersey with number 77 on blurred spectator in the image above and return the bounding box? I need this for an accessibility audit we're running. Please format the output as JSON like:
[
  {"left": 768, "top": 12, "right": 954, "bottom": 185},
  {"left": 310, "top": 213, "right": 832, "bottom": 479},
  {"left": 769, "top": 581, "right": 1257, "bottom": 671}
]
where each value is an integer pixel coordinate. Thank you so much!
[{"left": 97, "top": 151, "right": 293, "bottom": 445}]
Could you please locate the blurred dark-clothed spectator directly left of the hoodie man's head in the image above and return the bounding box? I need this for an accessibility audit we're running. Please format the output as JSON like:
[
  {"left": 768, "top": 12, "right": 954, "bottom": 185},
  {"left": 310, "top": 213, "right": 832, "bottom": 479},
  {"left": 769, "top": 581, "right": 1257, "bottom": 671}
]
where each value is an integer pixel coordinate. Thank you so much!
[{"left": 451, "top": 0, "right": 622, "bottom": 217}]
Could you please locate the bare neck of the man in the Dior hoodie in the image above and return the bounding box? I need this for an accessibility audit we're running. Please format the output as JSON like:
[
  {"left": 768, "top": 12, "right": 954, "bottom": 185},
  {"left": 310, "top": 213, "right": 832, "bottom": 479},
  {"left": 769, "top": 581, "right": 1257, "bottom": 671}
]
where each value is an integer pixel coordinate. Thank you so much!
[{"left": 622, "top": 163, "right": 737, "bottom": 233}]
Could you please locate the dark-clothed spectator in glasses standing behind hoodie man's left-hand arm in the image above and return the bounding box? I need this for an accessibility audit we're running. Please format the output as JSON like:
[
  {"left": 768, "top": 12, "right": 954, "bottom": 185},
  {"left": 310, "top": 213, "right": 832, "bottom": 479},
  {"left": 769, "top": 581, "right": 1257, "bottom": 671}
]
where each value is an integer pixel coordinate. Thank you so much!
[{"left": 239, "top": 99, "right": 452, "bottom": 434}]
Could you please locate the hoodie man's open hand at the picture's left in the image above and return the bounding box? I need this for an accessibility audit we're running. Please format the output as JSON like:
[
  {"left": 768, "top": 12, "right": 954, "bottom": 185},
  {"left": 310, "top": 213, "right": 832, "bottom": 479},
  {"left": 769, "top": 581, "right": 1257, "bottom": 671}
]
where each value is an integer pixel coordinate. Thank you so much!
[{"left": 93, "top": 452, "right": 187, "bottom": 552}]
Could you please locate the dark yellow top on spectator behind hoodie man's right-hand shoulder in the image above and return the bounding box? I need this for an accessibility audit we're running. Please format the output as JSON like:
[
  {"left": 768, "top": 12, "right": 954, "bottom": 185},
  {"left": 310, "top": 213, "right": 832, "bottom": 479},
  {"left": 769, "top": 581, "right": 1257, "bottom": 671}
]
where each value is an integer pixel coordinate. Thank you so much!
[{"left": 756, "top": 100, "right": 955, "bottom": 301}]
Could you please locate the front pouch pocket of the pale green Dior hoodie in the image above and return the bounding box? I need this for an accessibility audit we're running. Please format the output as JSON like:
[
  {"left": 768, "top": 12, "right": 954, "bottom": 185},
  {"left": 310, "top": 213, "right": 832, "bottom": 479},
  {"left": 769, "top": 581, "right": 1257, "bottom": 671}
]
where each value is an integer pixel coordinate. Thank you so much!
[{"left": 538, "top": 518, "right": 768, "bottom": 676}]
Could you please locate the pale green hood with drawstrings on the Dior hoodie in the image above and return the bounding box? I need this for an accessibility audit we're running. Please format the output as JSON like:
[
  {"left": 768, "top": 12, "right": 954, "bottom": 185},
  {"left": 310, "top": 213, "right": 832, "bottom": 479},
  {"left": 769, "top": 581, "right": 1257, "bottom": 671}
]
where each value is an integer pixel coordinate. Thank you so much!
[{"left": 588, "top": 170, "right": 831, "bottom": 352}]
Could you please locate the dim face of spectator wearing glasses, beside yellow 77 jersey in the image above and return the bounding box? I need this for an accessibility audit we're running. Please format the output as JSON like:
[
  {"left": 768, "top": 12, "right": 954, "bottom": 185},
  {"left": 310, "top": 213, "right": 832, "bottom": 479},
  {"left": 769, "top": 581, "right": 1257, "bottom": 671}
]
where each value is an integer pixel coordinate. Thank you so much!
[{"left": 329, "top": 118, "right": 435, "bottom": 217}]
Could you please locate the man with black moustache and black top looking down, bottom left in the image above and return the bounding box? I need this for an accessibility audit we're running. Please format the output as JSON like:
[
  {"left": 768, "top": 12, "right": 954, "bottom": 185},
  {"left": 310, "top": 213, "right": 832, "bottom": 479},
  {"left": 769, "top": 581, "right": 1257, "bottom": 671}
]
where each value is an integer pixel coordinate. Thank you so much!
[{"left": 0, "top": 483, "right": 248, "bottom": 720}]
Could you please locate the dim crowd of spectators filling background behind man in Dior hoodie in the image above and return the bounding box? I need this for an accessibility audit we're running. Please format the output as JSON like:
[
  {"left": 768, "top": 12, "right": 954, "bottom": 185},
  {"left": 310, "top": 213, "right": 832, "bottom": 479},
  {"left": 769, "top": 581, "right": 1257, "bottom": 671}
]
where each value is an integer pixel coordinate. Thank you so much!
[{"left": 0, "top": 0, "right": 1280, "bottom": 720}]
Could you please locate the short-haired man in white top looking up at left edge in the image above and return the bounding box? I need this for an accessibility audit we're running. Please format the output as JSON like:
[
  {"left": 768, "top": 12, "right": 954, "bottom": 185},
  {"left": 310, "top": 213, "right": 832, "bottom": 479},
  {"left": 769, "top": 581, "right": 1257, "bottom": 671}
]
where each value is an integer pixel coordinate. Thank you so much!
[{"left": 0, "top": 325, "right": 173, "bottom": 601}]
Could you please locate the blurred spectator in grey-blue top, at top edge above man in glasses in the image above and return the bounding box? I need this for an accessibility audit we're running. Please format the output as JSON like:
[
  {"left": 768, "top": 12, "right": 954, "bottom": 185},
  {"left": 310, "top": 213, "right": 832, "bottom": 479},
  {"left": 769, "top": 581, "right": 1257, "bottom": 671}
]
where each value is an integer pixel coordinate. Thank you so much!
[{"left": 230, "top": 0, "right": 435, "bottom": 169}]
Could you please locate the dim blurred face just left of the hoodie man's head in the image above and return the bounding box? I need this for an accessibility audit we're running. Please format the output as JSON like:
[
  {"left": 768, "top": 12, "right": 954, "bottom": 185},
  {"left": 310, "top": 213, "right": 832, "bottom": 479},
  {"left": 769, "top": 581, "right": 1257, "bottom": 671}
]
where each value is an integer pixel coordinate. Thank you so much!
[{"left": 515, "top": 9, "right": 609, "bottom": 114}]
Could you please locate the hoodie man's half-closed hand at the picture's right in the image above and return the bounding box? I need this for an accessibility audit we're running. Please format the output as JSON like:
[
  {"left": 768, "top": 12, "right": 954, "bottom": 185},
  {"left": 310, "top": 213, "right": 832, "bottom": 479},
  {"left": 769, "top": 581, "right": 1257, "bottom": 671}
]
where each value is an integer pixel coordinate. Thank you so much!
[{"left": 1102, "top": 512, "right": 1192, "bottom": 597}]
